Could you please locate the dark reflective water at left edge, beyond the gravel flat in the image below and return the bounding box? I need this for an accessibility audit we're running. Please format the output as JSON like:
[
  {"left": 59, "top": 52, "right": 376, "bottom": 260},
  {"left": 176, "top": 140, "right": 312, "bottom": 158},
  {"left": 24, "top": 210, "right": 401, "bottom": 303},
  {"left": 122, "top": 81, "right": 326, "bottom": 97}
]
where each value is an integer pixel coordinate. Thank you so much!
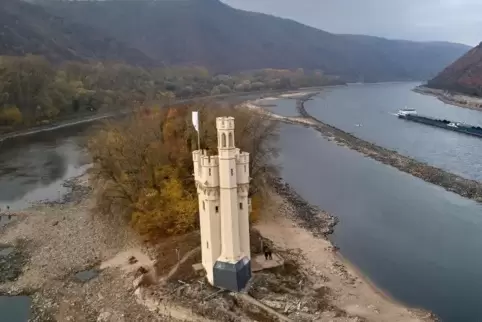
[{"left": 0, "top": 125, "right": 91, "bottom": 211}]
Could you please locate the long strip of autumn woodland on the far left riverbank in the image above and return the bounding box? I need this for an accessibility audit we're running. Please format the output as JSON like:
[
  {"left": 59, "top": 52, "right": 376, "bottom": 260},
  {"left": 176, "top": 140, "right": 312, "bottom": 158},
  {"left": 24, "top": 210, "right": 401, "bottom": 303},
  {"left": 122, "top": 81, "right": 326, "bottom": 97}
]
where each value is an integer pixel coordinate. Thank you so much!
[{"left": 0, "top": 55, "right": 339, "bottom": 132}]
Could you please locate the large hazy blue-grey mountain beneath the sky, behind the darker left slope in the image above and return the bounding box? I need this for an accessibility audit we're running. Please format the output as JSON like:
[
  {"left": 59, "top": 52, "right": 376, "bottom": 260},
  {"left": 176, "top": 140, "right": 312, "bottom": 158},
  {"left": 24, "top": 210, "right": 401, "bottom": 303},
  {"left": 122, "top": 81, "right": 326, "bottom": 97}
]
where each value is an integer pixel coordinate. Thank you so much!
[{"left": 39, "top": 0, "right": 468, "bottom": 81}]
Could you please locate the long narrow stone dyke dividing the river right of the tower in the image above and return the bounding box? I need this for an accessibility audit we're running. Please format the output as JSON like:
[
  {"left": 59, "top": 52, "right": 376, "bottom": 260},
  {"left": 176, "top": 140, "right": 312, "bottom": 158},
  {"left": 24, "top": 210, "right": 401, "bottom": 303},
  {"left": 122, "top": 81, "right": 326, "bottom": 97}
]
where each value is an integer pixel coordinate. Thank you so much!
[{"left": 274, "top": 93, "right": 482, "bottom": 202}]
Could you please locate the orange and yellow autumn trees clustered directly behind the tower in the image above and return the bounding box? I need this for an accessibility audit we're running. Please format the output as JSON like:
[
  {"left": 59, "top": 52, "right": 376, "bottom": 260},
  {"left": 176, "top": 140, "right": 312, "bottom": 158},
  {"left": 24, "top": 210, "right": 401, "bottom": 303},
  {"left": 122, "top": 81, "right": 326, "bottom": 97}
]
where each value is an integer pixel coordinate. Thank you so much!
[{"left": 88, "top": 104, "right": 277, "bottom": 238}]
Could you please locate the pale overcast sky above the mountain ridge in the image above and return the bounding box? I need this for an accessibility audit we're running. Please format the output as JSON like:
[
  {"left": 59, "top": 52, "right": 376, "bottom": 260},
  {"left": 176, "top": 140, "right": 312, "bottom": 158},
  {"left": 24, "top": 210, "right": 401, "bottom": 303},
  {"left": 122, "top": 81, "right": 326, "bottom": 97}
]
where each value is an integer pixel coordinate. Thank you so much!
[{"left": 222, "top": 0, "right": 482, "bottom": 46}]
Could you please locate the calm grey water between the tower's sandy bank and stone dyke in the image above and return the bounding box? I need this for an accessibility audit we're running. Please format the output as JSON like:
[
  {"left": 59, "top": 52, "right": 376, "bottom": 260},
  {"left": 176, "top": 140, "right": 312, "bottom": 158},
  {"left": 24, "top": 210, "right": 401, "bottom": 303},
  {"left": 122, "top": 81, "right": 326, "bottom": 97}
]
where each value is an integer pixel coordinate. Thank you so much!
[{"left": 280, "top": 125, "right": 482, "bottom": 321}]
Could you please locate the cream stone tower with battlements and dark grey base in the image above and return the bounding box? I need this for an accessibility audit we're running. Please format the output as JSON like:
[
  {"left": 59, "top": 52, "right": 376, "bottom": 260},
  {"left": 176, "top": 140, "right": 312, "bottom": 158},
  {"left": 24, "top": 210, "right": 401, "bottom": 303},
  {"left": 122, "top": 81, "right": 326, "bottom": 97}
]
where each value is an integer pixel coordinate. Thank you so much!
[{"left": 193, "top": 117, "right": 251, "bottom": 291}]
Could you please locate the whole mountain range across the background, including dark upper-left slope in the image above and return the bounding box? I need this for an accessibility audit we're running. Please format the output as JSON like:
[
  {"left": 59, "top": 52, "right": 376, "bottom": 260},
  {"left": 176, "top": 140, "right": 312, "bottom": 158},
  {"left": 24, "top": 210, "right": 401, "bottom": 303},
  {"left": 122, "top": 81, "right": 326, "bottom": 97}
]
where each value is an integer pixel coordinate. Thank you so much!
[{"left": 0, "top": 0, "right": 469, "bottom": 82}]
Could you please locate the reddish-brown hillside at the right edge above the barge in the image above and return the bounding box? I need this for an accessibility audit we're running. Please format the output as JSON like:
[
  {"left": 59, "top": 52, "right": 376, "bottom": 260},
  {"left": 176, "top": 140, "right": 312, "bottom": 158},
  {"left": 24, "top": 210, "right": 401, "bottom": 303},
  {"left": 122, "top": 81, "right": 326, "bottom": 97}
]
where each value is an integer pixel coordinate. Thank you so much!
[{"left": 427, "top": 42, "right": 482, "bottom": 96}]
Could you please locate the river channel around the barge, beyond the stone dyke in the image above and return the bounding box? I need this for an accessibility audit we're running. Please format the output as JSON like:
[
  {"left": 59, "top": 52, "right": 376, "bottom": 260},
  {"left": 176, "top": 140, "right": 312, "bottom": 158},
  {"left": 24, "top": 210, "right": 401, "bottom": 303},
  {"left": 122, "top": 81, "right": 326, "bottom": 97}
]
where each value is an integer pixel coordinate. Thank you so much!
[{"left": 306, "top": 83, "right": 482, "bottom": 181}]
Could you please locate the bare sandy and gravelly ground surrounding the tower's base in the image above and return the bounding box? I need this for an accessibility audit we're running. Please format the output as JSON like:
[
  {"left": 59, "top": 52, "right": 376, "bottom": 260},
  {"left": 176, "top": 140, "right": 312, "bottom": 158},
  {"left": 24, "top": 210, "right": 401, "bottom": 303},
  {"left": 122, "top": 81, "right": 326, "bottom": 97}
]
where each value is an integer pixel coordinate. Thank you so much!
[{"left": 0, "top": 167, "right": 433, "bottom": 322}]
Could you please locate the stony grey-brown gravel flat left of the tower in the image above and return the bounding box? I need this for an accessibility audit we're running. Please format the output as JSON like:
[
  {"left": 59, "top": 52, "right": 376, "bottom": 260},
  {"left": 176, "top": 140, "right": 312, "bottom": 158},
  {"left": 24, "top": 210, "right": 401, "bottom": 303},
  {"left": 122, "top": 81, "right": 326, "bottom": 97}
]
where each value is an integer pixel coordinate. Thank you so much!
[{"left": 0, "top": 177, "right": 166, "bottom": 322}]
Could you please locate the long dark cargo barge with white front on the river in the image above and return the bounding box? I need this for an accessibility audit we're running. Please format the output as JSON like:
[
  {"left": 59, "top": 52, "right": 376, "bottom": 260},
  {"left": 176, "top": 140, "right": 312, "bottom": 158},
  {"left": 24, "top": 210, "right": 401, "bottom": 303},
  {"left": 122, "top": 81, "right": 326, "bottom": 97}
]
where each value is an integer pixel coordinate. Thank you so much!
[{"left": 396, "top": 108, "right": 482, "bottom": 138}]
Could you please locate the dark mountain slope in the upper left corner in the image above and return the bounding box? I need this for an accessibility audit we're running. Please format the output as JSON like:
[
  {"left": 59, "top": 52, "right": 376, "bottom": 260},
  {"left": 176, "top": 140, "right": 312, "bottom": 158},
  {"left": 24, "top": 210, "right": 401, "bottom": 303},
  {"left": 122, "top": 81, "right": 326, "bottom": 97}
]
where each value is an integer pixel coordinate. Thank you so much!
[{"left": 0, "top": 0, "right": 152, "bottom": 64}]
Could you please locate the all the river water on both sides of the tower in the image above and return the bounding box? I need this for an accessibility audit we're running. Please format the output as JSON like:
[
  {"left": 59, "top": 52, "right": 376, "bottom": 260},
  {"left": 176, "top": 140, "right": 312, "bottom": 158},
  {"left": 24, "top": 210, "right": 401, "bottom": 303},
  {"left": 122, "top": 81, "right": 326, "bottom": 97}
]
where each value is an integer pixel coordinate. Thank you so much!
[{"left": 0, "top": 83, "right": 482, "bottom": 321}]
